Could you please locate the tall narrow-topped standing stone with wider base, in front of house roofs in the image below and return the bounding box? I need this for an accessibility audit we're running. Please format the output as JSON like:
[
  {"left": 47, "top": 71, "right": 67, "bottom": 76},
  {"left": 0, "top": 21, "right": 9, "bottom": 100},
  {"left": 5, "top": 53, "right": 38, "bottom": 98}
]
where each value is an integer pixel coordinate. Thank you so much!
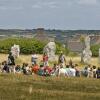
[{"left": 82, "top": 36, "right": 92, "bottom": 64}]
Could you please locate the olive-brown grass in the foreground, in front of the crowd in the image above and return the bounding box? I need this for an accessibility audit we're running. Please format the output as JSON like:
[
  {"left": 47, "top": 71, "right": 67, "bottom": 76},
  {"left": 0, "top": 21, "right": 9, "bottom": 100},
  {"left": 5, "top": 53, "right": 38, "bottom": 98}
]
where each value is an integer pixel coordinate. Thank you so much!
[{"left": 0, "top": 74, "right": 100, "bottom": 100}]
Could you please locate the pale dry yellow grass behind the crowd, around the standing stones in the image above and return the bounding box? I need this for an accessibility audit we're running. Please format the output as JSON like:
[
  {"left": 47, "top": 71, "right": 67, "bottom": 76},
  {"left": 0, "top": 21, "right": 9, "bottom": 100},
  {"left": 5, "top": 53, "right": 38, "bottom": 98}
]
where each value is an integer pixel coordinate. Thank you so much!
[{"left": 0, "top": 54, "right": 100, "bottom": 66}]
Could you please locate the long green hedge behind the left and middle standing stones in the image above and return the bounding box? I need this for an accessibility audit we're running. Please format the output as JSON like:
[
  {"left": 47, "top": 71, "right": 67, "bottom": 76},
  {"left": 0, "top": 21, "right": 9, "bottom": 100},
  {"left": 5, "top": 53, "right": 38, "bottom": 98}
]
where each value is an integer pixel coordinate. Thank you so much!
[{"left": 0, "top": 38, "right": 69, "bottom": 54}]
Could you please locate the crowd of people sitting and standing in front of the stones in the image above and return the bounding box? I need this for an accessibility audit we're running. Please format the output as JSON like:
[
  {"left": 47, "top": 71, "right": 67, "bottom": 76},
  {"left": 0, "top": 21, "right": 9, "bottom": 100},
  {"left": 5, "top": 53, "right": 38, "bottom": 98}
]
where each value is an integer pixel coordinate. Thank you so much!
[{"left": 0, "top": 53, "right": 100, "bottom": 78}]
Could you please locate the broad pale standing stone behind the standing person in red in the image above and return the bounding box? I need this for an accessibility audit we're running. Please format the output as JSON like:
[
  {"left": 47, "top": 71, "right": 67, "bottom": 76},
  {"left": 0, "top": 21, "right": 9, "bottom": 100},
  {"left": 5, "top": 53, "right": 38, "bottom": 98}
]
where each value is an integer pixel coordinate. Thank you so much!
[{"left": 43, "top": 42, "right": 56, "bottom": 61}]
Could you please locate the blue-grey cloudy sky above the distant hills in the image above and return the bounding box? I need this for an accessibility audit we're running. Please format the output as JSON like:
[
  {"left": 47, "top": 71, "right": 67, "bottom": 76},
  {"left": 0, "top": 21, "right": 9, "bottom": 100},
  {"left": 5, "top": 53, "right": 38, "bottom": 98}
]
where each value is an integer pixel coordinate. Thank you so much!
[{"left": 0, "top": 0, "right": 100, "bottom": 29}]
